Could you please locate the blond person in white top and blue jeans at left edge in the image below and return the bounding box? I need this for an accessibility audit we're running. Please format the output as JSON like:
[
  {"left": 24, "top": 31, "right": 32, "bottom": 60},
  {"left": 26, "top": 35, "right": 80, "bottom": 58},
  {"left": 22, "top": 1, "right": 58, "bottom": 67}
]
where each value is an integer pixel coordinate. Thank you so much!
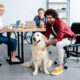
[{"left": 0, "top": 4, "right": 19, "bottom": 62}]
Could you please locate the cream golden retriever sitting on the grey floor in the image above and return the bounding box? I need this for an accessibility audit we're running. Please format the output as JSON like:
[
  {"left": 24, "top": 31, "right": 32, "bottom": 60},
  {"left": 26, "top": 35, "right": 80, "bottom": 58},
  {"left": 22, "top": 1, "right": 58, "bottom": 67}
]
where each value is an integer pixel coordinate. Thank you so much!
[{"left": 22, "top": 32, "right": 52, "bottom": 75}]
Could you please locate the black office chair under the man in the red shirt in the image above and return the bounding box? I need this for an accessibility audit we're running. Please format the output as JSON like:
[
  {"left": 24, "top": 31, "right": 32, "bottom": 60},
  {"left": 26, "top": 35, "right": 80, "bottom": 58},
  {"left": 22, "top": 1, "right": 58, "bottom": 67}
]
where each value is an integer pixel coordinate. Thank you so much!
[{"left": 64, "top": 23, "right": 80, "bottom": 69}]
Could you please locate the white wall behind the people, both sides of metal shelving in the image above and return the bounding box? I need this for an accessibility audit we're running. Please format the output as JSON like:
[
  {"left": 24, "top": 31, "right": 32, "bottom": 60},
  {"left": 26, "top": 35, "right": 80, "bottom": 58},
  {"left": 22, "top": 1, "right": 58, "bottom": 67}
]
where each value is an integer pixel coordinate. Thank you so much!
[{"left": 0, "top": 0, "right": 80, "bottom": 24}]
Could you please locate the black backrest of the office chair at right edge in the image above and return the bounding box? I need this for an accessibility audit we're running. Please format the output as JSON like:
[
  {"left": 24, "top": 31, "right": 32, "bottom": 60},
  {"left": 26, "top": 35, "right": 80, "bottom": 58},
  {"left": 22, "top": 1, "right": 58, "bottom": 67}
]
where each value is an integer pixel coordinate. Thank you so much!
[{"left": 71, "top": 23, "right": 80, "bottom": 43}]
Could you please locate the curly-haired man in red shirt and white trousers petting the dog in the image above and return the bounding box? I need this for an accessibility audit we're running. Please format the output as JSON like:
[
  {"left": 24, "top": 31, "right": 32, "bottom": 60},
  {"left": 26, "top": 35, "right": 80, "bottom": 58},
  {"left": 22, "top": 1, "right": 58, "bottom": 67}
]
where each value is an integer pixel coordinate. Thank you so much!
[{"left": 43, "top": 9, "right": 76, "bottom": 75}]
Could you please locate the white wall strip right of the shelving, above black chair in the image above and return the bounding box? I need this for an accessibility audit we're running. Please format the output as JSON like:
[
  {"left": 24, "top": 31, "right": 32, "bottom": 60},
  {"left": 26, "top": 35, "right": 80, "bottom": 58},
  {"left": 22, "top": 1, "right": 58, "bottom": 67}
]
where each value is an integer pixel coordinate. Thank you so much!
[{"left": 70, "top": 0, "right": 80, "bottom": 24}]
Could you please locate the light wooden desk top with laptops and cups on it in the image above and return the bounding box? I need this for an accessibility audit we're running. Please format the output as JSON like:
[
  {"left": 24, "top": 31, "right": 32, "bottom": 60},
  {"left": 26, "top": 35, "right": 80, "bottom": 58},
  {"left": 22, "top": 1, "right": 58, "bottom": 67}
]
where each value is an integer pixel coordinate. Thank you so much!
[{"left": 4, "top": 28, "right": 46, "bottom": 32}]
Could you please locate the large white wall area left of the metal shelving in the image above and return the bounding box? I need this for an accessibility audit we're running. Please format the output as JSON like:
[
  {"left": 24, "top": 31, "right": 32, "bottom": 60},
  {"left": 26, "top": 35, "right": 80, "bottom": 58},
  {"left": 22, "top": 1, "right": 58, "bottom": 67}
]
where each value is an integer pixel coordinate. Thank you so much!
[{"left": 0, "top": 0, "right": 46, "bottom": 24}]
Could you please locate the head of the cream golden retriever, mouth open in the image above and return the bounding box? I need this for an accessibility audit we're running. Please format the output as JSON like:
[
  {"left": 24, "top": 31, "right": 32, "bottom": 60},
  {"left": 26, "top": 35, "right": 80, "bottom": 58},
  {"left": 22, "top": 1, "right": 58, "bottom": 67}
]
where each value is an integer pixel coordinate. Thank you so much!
[{"left": 32, "top": 32, "right": 47, "bottom": 45}]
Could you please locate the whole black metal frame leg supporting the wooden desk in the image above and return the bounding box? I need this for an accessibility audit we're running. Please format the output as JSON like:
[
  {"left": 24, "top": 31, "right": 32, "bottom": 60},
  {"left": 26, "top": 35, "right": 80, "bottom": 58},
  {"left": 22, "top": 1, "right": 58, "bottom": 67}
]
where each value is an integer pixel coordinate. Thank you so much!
[{"left": 7, "top": 32, "right": 24, "bottom": 64}]
